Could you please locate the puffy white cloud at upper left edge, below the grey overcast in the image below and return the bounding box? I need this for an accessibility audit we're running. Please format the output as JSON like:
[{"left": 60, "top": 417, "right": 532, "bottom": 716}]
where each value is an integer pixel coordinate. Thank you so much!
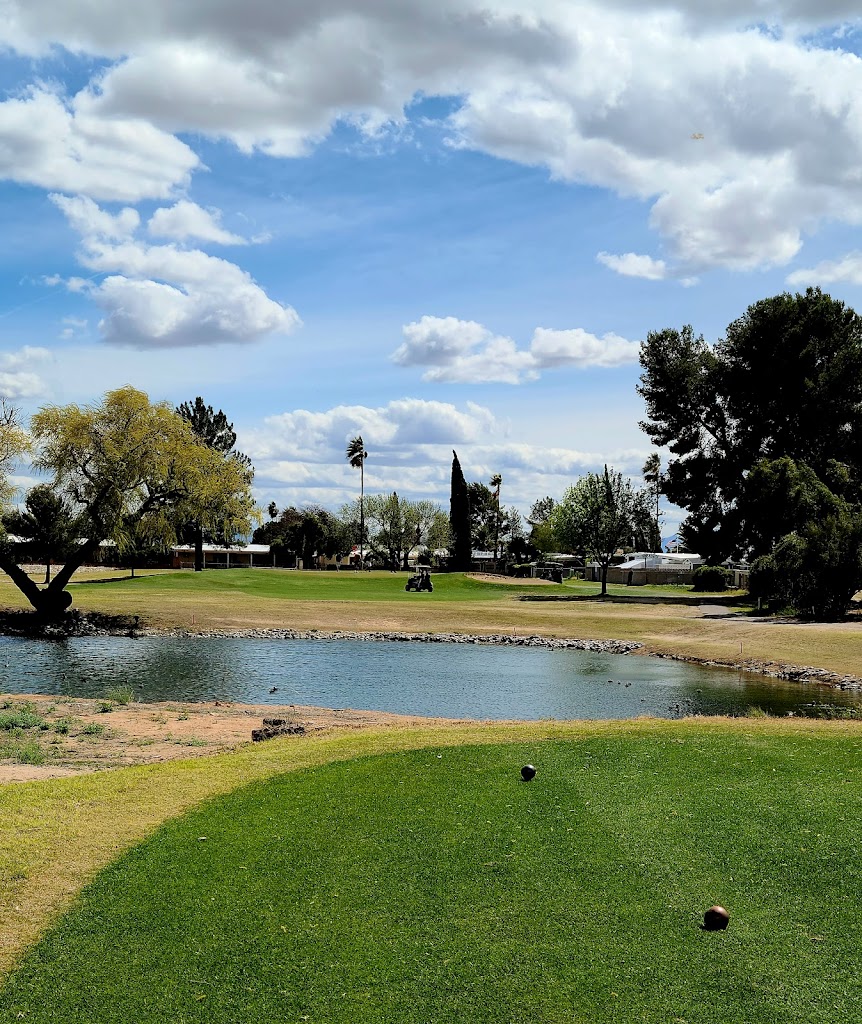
[{"left": 0, "top": 88, "right": 200, "bottom": 202}]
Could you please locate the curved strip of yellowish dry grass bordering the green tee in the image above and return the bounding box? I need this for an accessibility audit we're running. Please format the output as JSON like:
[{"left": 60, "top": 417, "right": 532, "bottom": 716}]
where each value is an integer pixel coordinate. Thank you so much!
[{"left": 0, "top": 719, "right": 858, "bottom": 973}]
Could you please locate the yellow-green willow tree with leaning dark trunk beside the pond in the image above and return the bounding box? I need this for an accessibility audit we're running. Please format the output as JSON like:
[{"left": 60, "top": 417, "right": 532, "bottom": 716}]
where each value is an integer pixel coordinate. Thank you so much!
[{"left": 0, "top": 387, "right": 257, "bottom": 615}]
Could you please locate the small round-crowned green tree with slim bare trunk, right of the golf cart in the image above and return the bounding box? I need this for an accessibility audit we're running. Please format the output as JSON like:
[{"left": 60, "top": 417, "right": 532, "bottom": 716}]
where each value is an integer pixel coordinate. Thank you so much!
[{"left": 550, "top": 466, "right": 650, "bottom": 596}]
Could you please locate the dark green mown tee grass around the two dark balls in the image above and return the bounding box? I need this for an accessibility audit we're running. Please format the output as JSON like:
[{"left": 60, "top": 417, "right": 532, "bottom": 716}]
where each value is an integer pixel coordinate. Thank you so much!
[{"left": 6, "top": 724, "right": 862, "bottom": 1024}]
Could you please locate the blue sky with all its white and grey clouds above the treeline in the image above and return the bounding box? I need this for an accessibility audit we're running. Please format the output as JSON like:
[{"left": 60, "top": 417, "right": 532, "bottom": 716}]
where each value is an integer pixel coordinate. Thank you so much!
[{"left": 0, "top": 0, "right": 862, "bottom": 535}]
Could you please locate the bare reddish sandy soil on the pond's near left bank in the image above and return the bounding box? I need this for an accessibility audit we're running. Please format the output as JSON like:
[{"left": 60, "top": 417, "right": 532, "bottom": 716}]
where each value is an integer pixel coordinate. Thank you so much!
[{"left": 0, "top": 694, "right": 460, "bottom": 783}]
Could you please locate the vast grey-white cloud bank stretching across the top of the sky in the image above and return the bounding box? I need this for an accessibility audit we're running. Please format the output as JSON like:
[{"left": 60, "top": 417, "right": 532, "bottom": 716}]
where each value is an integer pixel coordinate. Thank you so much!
[{"left": 0, "top": 0, "right": 862, "bottom": 272}]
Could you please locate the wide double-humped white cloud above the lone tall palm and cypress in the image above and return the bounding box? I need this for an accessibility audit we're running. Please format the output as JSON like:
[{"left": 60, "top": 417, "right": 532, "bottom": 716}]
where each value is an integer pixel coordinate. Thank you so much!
[{"left": 392, "top": 316, "right": 639, "bottom": 384}]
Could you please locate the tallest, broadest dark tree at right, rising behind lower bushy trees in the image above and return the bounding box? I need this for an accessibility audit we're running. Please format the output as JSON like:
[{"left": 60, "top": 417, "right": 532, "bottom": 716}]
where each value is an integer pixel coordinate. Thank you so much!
[{"left": 638, "top": 288, "right": 862, "bottom": 563}]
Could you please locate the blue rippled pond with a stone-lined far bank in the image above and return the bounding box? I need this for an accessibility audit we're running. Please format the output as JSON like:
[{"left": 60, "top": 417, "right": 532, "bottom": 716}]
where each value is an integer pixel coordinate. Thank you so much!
[{"left": 0, "top": 637, "right": 862, "bottom": 719}]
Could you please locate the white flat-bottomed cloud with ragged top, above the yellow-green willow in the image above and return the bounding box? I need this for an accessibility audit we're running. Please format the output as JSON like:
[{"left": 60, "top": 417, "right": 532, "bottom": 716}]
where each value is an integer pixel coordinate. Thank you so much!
[{"left": 51, "top": 196, "right": 300, "bottom": 348}]
